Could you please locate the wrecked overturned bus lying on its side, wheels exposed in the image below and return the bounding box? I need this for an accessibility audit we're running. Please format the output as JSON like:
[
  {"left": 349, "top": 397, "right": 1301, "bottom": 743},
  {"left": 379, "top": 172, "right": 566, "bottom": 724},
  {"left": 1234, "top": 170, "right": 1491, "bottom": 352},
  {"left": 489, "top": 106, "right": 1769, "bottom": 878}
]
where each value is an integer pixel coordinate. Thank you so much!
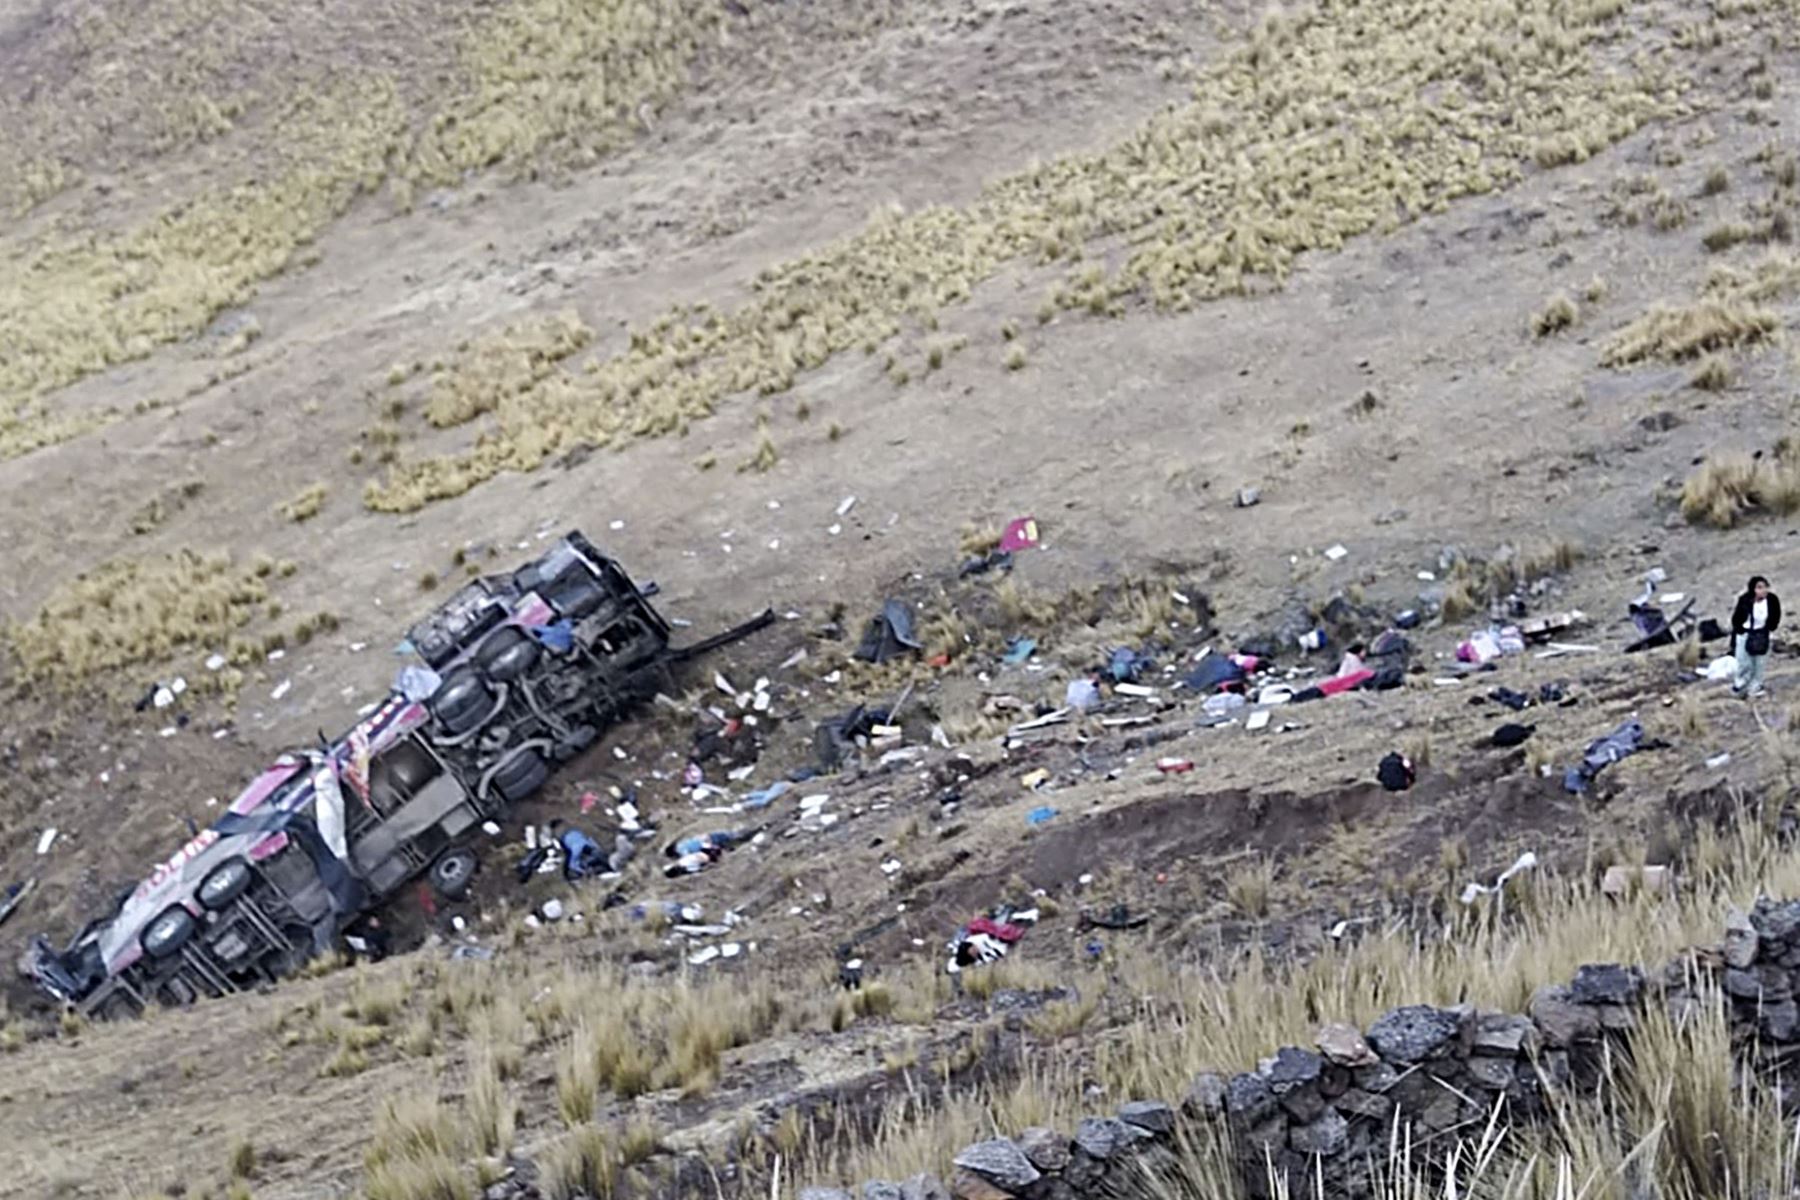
[{"left": 25, "top": 533, "right": 772, "bottom": 1016}]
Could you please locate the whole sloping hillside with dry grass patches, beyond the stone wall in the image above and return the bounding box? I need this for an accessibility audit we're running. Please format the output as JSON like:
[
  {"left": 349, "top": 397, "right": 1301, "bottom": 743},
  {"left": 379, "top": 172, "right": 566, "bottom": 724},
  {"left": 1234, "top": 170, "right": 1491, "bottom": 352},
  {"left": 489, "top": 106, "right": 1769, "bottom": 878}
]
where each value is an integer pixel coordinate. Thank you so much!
[{"left": 0, "top": 0, "right": 1800, "bottom": 1200}]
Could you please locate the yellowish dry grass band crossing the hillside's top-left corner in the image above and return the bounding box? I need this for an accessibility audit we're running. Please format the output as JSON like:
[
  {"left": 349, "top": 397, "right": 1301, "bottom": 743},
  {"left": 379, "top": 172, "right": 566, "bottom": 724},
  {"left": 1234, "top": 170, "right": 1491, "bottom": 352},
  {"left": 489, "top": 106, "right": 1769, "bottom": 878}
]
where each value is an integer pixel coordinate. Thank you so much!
[{"left": 0, "top": 0, "right": 724, "bottom": 457}]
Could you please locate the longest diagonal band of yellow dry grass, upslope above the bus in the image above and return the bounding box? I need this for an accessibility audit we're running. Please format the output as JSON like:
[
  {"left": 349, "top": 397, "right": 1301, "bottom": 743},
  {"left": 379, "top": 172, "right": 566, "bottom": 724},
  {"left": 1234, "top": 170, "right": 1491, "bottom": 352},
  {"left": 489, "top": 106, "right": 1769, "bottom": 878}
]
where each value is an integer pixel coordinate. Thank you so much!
[{"left": 367, "top": 0, "right": 1679, "bottom": 511}]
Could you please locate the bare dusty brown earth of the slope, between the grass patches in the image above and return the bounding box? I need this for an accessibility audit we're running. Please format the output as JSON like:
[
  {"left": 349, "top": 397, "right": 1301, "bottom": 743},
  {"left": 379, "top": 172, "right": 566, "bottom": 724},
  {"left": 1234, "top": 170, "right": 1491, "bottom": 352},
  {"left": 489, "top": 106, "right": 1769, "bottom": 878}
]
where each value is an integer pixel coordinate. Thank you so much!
[{"left": 0, "top": 0, "right": 1800, "bottom": 1198}]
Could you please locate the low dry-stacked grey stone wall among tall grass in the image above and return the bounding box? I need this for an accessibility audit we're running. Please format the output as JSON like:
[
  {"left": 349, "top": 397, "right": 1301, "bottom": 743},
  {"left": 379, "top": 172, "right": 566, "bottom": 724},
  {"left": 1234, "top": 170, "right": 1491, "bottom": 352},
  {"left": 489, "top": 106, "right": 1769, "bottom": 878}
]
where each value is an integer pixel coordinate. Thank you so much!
[{"left": 799, "top": 901, "right": 1800, "bottom": 1200}]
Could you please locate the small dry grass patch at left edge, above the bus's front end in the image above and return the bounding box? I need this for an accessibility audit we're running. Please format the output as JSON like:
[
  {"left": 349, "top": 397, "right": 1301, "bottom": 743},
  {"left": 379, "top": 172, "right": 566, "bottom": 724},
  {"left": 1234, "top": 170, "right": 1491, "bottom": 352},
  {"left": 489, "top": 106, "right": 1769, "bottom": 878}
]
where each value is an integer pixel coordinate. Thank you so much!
[{"left": 5, "top": 551, "right": 277, "bottom": 685}]
